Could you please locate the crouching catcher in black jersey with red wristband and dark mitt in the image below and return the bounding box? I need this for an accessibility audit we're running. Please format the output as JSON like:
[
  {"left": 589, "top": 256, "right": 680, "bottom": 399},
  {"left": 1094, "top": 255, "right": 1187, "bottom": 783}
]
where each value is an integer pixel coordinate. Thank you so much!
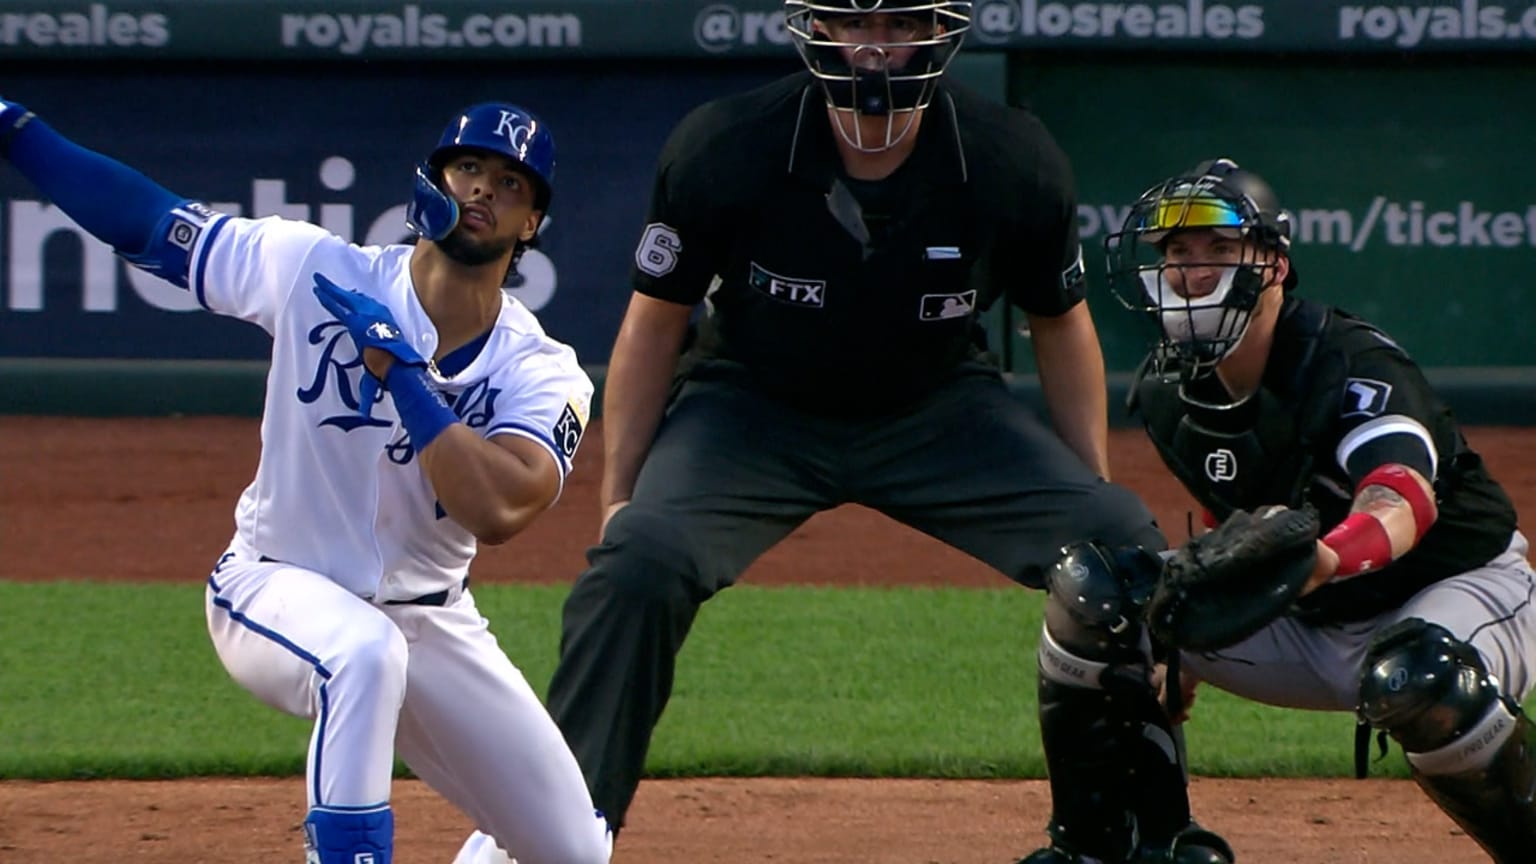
[{"left": 1087, "top": 160, "right": 1536, "bottom": 862}]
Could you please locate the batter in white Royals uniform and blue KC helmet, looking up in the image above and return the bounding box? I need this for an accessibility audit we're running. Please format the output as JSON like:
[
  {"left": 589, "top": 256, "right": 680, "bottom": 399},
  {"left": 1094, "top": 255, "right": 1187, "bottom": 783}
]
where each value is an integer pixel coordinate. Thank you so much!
[{"left": 0, "top": 95, "right": 611, "bottom": 864}]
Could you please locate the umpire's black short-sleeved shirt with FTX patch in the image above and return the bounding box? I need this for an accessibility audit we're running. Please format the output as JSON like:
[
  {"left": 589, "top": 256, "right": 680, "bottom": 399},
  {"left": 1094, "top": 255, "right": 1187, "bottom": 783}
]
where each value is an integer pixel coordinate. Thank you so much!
[{"left": 634, "top": 72, "right": 1084, "bottom": 415}]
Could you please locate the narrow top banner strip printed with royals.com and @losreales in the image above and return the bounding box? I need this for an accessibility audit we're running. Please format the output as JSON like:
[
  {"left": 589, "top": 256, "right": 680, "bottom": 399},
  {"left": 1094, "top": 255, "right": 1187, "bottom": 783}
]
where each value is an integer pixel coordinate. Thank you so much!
[{"left": 0, "top": 0, "right": 1536, "bottom": 61}]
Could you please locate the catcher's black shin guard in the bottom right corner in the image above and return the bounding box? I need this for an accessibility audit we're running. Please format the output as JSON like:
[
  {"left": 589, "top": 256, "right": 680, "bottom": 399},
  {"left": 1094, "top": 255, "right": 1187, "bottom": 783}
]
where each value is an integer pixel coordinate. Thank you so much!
[{"left": 1359, "top": 618, "right": 1536, "bottom": 864}]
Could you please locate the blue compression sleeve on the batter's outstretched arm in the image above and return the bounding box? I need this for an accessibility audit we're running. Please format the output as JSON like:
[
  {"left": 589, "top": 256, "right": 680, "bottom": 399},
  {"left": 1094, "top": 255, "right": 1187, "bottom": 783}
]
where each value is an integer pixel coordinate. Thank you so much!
[{"left": 6, "top": 105, "right": 186, "bottom": 250}]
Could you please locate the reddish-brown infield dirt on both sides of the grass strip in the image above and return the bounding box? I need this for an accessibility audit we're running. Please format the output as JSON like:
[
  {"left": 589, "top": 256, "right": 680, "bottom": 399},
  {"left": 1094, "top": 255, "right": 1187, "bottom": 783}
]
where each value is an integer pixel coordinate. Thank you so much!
[{"left": 0, "top": 417, "right": 1536, "bottom": 864}]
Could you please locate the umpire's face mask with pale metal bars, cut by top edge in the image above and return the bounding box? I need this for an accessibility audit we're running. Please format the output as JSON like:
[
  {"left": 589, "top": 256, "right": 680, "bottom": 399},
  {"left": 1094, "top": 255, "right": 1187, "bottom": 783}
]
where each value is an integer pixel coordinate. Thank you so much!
[{"left": 783, "top": 0, "right": 971, "bottom": 152}]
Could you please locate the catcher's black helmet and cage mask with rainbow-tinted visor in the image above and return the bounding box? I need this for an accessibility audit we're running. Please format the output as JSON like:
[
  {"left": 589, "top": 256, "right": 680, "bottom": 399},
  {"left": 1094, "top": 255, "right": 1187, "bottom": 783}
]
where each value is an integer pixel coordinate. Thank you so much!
[{"left": 1104, "top": 158, "right": 1296, "bottom": 378}]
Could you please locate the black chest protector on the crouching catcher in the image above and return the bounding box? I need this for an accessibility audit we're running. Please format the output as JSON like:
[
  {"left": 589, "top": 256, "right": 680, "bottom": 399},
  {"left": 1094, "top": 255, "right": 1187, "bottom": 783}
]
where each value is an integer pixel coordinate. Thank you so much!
[{"left": 1130, "top": 303, "right": 1347, "bottom": 520}]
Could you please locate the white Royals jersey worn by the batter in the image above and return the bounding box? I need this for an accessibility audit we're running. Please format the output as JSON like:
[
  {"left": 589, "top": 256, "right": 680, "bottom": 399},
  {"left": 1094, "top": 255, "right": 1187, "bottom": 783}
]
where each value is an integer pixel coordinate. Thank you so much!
[{"left": 187, "top": 214, "right": 593, "bottom": 601}]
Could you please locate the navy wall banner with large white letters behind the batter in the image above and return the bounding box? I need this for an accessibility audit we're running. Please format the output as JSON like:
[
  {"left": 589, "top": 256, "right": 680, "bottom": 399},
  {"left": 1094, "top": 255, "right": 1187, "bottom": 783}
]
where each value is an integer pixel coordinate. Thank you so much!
[{"left": 0, "top": 58, "right": 799, "bottom": 363}]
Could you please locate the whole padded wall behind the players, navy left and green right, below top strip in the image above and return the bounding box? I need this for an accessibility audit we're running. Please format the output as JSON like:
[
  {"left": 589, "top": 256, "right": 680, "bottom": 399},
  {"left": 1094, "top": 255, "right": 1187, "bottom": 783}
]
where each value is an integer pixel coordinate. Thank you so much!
[{"left": 0, "top": 52, "right": 1536, "bottom": 424}]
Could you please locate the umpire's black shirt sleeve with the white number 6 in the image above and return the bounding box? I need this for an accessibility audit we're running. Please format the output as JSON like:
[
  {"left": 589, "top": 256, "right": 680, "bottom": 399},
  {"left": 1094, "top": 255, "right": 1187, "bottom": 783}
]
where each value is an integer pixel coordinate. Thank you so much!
[{"left": 633, "top": 106, "right": 731, "bottom": 306}]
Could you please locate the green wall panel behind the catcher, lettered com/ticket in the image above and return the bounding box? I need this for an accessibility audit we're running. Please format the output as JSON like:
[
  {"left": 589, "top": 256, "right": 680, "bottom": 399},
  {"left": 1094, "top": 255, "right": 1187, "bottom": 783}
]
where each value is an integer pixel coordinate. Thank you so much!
[{"left": 1012, "top": 58, "right": 1536, "bottom": 369}]
